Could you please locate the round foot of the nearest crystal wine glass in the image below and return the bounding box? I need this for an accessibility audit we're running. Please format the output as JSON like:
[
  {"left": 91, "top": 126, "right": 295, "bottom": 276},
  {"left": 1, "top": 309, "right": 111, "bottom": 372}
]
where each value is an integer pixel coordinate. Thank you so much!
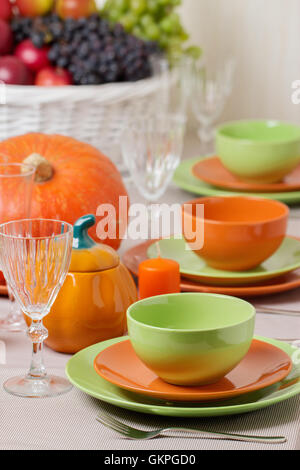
[{"left": 3, "top": 375, "right": 72, "bottom": 398}]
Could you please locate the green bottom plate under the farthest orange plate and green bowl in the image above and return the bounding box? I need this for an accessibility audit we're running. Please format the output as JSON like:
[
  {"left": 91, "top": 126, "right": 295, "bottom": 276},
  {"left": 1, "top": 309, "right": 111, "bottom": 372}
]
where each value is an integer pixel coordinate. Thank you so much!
[{"left": 174, "top": 157, "right": 300, "bottom": 204}]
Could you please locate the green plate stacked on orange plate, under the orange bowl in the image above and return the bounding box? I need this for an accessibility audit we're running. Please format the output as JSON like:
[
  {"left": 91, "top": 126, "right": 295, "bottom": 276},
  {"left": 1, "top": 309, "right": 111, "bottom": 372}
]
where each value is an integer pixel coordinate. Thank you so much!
[{"left": 123, "top": 237, "right": 300, "bottom": 297}]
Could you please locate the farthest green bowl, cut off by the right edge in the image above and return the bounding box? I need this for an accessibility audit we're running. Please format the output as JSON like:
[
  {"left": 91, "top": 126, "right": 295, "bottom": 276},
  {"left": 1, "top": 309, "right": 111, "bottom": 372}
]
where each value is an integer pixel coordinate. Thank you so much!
[{"left": 216, "top": 121, "right": 300, "bottom": 183}]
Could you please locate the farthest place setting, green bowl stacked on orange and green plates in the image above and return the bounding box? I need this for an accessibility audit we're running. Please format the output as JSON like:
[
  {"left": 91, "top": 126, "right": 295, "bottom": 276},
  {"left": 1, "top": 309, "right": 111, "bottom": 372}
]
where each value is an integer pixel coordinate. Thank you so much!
[{"left": 175, "top": 121, "right": 300, "bottom": 204}]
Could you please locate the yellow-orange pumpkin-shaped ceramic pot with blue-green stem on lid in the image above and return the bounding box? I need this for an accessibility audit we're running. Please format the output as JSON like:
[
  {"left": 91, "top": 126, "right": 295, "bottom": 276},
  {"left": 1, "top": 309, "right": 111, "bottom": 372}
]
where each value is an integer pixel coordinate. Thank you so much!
[{"left": 39, "top": 215, "right": 137, "bottom": 353}]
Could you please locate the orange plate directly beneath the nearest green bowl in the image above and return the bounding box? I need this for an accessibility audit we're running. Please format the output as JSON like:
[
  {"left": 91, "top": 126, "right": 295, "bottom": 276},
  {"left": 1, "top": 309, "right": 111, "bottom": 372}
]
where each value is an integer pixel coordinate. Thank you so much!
[{"left": 94, "top": 339, "right": 292, "bottom": 402}]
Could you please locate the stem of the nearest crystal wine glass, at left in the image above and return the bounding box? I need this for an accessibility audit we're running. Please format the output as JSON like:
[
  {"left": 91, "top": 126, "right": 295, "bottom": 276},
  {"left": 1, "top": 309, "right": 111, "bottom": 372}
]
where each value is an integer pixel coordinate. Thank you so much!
[{"left": 27, "top": 320, "right": 48, "bottom": 380}]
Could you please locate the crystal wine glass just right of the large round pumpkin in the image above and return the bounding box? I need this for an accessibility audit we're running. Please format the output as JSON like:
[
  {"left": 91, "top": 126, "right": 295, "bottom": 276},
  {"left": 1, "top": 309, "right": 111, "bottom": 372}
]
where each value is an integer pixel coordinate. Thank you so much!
[{"left": 121, "top": 114, "right": 186, "bottom": 238}]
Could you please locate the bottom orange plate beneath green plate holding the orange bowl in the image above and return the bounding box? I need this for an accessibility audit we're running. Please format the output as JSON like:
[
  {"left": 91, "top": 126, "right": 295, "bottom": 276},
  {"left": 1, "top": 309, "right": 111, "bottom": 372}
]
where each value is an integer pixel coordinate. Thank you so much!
[{"left": 123, "top": 240, "right": 300, "bottom": 297}]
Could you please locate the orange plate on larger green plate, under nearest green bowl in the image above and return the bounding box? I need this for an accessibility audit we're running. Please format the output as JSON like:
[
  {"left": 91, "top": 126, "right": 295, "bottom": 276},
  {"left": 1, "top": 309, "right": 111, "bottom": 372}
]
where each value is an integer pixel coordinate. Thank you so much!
[{"left": 66, "top": 337, "right": 300, "bottom": 417}]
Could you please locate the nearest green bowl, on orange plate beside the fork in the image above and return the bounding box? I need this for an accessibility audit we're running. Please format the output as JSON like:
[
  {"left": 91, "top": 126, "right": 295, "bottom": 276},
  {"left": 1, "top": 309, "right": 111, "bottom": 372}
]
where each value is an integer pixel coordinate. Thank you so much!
[{"left": 127, "top": 293, "right": 255, "bottom": 386}]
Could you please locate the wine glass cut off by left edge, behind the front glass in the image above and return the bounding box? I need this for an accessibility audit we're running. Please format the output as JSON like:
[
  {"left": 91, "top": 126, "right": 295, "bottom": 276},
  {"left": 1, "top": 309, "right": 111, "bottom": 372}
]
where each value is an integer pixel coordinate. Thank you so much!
[{"left": 0, "top": 163, "right": 35, "bottom": 331}]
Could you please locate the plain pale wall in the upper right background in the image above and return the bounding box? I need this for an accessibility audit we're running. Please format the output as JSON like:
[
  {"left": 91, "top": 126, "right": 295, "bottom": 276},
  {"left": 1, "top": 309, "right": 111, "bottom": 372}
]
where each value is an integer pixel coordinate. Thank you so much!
[{"left": 182, "top": 0, "right": 300, "bottom": 122}]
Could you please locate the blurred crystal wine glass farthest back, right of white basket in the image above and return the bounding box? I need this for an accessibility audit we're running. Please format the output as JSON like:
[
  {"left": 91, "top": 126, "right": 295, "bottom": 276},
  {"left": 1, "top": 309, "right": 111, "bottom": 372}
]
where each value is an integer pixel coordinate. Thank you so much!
[{"left": 192, "top": 59, "right": 235, "bottom": 144}]
